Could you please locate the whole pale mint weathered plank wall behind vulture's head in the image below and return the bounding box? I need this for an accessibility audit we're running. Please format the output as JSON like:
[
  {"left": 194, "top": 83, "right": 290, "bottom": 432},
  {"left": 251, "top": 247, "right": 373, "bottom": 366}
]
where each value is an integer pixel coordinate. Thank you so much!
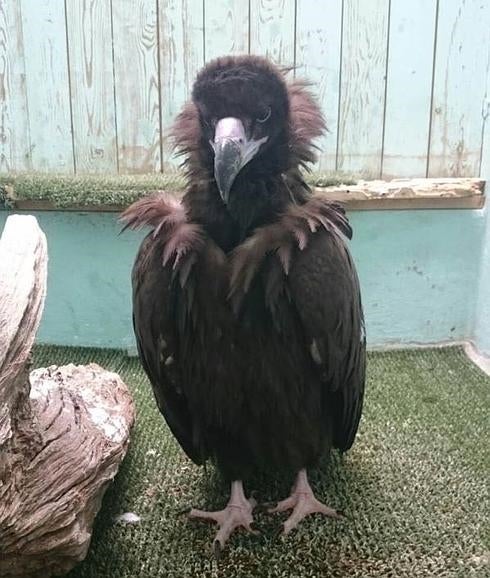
[{"left": 0, "top": 0, "right": 490, "bottom": 176}]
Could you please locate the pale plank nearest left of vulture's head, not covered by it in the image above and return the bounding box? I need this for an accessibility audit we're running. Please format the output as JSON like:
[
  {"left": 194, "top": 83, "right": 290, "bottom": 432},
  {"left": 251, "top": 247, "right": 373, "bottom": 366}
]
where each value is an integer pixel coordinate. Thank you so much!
[{"left": 112, "top": 0, "right": 161, "bottom": 173}]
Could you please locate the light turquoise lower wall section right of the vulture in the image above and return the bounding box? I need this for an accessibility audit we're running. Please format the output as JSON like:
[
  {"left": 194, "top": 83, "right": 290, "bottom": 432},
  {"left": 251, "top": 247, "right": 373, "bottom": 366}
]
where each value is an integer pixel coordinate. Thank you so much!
[{"left": 350, "top": 210, "right": 484, "bottom": 346}]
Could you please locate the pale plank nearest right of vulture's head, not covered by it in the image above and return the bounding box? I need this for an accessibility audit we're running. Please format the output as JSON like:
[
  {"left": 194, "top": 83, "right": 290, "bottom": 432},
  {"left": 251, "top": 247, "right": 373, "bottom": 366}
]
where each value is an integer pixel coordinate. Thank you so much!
[{"left": 337, "top": 0, "right": 389, "bottom": 177}]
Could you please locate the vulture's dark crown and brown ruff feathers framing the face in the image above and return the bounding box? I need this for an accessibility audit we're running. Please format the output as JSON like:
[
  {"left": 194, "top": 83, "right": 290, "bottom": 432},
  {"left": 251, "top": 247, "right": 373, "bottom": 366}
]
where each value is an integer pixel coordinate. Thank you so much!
[{"left": 171, "top": 55, "right": 326, "bottom": 182}]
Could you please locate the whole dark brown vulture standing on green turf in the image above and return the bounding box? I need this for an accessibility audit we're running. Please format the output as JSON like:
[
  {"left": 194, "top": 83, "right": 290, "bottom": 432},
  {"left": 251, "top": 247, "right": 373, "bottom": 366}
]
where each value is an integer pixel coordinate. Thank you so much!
[{"left": 122, "top": 55, "right": 366, "bottom": 554}]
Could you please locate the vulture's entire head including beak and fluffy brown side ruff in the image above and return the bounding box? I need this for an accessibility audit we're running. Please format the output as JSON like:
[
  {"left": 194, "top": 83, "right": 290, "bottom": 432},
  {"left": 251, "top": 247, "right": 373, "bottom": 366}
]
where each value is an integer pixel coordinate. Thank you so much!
[{"left": 174, "top": 55, "right": 324, "bottom": 203}]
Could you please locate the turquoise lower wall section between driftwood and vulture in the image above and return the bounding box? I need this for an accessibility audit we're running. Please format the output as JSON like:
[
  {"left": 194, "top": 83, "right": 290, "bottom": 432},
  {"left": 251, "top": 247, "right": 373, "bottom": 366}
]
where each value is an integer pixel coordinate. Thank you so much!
[{"left": 0, "top": 211, "right": 141, "bottom": 348}]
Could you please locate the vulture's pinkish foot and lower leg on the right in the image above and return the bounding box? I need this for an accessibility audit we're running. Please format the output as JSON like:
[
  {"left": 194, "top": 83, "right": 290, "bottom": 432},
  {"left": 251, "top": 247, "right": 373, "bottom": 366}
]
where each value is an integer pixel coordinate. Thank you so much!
[{"left": 269, "top": 470, "right": 343, "bottom": 534}]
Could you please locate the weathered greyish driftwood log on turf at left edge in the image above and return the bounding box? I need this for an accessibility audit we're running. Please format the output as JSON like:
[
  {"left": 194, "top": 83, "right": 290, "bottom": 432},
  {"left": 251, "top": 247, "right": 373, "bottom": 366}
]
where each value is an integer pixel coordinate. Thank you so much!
[{"left": 0, "top": 216, "right": 134, "bottom": 578}]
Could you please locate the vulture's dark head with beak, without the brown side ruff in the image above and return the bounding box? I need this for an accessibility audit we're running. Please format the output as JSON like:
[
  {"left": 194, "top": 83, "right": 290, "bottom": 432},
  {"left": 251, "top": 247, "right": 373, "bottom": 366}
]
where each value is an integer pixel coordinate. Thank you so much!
[{"left": 192, "top": 56, "right": 289, "bottom": 202}]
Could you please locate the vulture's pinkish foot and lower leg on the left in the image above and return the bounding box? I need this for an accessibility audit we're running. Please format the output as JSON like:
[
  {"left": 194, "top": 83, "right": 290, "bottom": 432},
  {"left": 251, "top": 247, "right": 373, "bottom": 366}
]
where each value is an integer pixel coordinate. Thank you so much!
[{"left": 189, "top": 480, "right": 257, "bottom": 555}]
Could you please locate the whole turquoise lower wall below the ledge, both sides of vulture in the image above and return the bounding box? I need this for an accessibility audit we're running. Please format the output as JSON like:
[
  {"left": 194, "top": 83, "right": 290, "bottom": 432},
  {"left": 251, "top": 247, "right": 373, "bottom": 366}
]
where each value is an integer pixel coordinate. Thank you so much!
[{"left": 0, "top": 210, "right": 484, "bottom": 349}]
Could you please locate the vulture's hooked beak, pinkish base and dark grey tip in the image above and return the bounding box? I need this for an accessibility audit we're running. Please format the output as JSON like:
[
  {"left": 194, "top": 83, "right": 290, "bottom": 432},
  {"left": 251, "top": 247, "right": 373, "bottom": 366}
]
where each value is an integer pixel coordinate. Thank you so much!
[{"left": 210, "top": 117, "right": 267, "bottom": 203}]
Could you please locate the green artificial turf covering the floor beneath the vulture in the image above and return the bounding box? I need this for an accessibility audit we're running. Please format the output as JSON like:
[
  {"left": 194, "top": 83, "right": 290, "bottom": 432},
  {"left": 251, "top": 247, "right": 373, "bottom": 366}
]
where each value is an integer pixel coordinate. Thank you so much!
[{"left": 34, "top": 347, "right": 490, "bottom": 578}]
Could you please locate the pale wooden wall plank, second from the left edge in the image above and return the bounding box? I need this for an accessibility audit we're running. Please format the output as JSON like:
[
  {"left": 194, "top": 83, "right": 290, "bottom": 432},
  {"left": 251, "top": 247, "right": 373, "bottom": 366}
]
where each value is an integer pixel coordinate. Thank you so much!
[{"left": 20, "top": 0, "right": 74, "bottom": 173}]
